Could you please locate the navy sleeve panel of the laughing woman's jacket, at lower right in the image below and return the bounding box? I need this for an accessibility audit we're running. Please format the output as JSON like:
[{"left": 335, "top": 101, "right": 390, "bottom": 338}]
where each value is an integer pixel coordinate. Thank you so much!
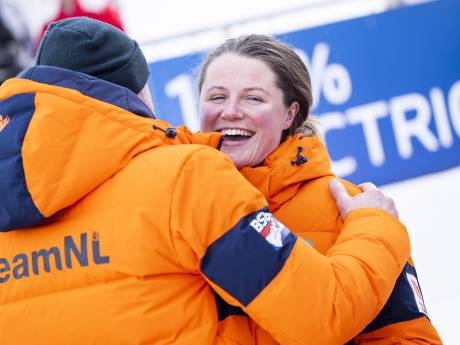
[{"left": 363, "top": 264, "right": 426, "bottom": 333}]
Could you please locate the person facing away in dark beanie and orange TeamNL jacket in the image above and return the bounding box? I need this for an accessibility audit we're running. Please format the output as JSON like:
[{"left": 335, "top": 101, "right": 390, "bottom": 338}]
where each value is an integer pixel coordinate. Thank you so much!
[{"left": 0, "top": 18, "right": 410, "bottom": 345}]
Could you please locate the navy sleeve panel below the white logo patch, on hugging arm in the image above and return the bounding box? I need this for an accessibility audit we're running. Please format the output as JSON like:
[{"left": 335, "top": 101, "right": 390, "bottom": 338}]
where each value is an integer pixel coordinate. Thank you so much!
[{"left": 201, "top": 209, "right": 297, "bottom": 306}]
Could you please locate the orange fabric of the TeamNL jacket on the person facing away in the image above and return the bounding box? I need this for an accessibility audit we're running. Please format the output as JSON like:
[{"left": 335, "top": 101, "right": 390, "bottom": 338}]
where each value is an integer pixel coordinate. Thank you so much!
[{"left": 0, "top": 79, "right": 409, "bottom": 345}]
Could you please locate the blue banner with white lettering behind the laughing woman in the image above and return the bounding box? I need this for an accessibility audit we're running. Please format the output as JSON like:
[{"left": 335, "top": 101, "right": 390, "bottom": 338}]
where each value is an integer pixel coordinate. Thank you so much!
[{"left": 150, "top": 0, "right": 460, "bottom": 184}]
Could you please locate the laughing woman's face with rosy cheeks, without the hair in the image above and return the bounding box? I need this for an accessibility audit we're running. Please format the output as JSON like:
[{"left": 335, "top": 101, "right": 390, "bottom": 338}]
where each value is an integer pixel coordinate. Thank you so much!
[{"left": 200, "top": 53, "right": 299, "bottom": 168}]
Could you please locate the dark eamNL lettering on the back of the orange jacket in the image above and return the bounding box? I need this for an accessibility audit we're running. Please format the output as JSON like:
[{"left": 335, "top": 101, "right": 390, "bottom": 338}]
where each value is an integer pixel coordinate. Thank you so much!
[{"left": 0, "top": 232, "right": 110, "bottom": 284}]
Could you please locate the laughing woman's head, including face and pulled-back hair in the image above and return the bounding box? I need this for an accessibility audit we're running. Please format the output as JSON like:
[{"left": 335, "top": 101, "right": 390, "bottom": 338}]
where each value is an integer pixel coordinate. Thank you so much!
[{"left": 198, "top": 35, "right": 314, "bottom": 168}]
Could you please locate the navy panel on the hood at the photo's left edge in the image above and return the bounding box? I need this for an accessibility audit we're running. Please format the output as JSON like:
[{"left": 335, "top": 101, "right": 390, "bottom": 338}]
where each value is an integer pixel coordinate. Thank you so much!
[{"left": 0, "top": 93, "right": 44, "bottom": 232}]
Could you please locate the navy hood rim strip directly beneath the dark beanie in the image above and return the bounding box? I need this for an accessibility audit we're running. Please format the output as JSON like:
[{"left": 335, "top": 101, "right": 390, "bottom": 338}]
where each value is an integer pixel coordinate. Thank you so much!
[{"left": 17, "top": 66, "right": 155, "bottom": 118}]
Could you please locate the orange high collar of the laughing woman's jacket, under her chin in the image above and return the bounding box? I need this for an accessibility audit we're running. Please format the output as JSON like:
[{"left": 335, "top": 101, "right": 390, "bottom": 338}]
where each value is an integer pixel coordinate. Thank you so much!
[{"left": 241, "top": 135, "right": 333, "bottom": 212}]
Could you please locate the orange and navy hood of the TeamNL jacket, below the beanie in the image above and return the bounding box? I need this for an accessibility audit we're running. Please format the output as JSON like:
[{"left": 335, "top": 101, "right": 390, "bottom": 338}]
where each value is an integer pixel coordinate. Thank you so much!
[{"left": 0, "top": 66, "right": 220, "bottom": 231}]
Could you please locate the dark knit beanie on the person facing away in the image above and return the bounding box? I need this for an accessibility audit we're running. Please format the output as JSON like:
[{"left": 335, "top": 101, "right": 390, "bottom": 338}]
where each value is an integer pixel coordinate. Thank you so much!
[{"left": 36, "top": 17, "right": 149, "bottom": 94}]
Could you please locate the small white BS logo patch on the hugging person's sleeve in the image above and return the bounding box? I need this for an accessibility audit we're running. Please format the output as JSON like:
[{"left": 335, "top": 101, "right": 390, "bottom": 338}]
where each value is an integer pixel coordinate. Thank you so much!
[{"left": 249, "top": 212, "right": 289, "bottom": 249}]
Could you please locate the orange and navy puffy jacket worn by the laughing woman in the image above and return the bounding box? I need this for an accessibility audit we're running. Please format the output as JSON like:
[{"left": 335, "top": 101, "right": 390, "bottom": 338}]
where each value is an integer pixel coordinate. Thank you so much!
[{"left": 234, "top": 135, "right": 441, "bottom": 345}]
